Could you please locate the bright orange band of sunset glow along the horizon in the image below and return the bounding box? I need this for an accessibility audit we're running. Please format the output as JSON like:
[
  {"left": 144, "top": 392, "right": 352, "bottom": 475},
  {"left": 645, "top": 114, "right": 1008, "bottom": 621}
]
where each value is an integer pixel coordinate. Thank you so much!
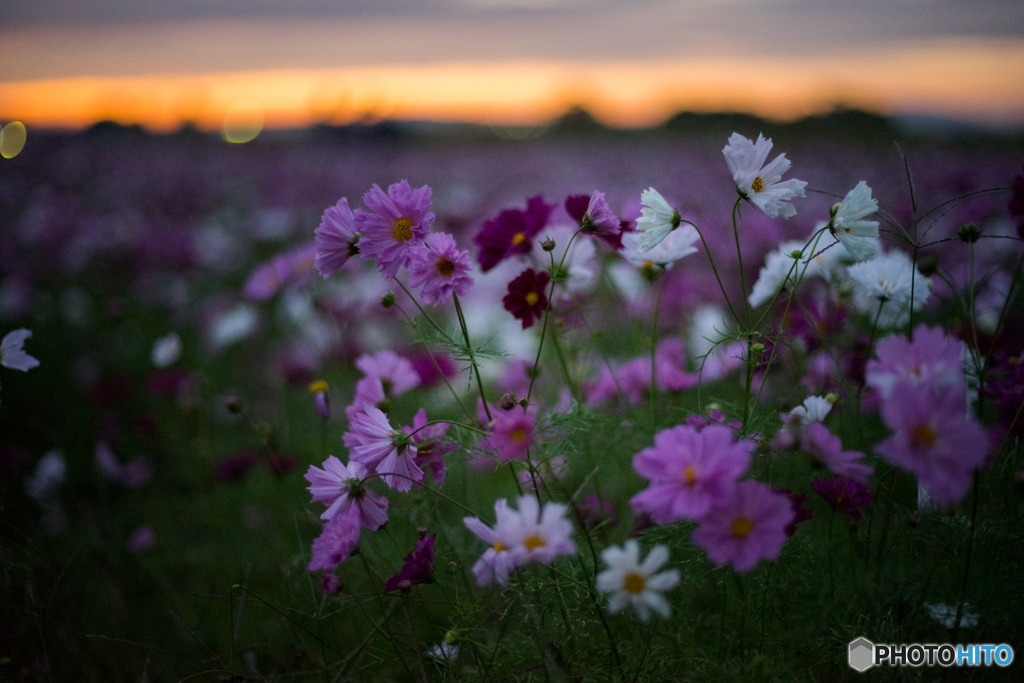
[{"left": 0, "top": 40, "right": 1024, "bottom": 131}]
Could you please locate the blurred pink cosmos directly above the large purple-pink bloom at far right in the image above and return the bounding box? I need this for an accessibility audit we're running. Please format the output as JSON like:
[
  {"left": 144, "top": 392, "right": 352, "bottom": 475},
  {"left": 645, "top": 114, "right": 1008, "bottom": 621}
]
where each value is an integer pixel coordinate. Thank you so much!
[{"left": 864, "top": 325, "right": 964, "bottom": 398}]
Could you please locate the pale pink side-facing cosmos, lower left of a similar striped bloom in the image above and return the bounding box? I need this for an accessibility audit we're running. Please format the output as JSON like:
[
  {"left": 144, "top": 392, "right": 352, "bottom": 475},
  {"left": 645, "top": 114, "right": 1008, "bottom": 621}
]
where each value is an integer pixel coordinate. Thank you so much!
[{"left": 305, "top": 456, "right": 388, "bottom": 531}]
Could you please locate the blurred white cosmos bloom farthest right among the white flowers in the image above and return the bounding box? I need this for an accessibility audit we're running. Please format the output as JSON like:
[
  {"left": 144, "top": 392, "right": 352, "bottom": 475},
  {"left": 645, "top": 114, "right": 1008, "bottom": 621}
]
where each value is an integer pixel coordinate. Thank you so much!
[{"left": 847, "top": 251, "right": 932, "bottom": 329}]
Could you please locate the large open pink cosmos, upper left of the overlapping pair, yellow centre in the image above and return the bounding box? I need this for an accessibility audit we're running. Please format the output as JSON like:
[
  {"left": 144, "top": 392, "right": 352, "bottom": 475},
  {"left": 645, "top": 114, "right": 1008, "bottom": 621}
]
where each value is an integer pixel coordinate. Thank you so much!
[{"left": 630, "top": 425, "right": 754, "bottom": 524}]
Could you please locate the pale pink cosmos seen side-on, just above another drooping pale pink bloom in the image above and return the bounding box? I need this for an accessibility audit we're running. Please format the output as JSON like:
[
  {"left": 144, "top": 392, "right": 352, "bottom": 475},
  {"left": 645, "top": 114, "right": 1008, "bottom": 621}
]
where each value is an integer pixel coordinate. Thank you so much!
[{"left": 342, "top": 405, "right": 425, "bottom": 490}]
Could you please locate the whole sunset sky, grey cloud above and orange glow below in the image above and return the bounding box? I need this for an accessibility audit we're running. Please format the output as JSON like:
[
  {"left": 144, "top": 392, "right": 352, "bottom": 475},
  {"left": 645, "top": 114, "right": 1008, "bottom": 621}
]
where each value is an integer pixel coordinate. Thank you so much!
[{"left": 0, "top": 0, "right": 1024, "bottom": 130}]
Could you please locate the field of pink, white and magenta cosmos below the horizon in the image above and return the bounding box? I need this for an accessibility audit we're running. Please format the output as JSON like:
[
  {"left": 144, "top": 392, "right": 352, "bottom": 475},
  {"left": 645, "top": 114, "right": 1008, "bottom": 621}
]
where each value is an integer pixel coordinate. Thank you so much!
[{"left": 0, "top": 119, "right": 1024, "bottom": 682}]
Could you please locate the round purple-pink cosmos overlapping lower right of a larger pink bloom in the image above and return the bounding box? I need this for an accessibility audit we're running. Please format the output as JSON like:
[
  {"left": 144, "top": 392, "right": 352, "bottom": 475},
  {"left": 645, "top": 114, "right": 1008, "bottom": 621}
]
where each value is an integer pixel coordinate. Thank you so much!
[{"left": 692, "top": 481, "right": 796, "bottom": 571}]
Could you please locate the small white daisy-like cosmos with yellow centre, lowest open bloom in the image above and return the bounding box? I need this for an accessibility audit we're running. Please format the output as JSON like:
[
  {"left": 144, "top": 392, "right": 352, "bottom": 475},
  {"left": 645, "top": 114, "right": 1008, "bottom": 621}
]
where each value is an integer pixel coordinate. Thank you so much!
[{"left": 597, "top": 540, "right": 680, "bottom": 622}]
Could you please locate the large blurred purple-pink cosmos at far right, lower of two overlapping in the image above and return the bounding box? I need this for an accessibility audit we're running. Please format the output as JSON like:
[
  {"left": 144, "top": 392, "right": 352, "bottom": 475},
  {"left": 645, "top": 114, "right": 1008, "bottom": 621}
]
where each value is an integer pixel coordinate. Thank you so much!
[{"left": 874, "top": 380, "right": 989, "bottom": 505}]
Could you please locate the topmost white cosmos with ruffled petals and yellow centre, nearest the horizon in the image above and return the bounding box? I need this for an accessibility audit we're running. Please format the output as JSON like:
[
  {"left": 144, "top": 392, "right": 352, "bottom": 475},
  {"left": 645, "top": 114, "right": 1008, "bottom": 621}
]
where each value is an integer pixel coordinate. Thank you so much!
[{"left": 722, "top": 133, "right": 807, "bottom": 218}]
